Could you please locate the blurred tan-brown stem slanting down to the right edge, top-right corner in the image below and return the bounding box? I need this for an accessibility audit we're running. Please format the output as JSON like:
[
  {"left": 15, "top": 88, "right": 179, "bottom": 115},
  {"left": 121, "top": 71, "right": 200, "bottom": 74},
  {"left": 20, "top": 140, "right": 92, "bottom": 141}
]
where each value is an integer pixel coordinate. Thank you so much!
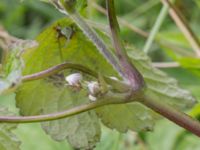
[{"left": 162, "top": 0, "right": 200, "bottom": 57}]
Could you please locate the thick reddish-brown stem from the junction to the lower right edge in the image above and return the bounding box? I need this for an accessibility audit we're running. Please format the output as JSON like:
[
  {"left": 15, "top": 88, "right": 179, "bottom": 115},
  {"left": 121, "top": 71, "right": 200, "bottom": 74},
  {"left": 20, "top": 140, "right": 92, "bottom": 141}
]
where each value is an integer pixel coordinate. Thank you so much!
[{"left": 140, "top": 96, "right": 200, "bottom": 137}]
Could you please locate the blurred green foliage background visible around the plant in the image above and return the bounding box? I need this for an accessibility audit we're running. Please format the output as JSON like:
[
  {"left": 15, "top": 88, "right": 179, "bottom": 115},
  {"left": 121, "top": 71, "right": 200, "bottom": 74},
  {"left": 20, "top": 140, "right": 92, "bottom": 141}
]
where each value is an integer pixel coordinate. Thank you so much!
[{"left": 0, "top": 0, "right": 200, "bottom": 150}]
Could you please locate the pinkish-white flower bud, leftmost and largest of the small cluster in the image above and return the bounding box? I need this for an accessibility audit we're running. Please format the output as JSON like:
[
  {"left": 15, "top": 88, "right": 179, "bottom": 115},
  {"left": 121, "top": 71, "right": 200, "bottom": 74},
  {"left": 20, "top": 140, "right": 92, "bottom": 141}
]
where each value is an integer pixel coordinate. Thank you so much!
[{"left": 65, "top": 73, "right": 83, "bottom": 86}]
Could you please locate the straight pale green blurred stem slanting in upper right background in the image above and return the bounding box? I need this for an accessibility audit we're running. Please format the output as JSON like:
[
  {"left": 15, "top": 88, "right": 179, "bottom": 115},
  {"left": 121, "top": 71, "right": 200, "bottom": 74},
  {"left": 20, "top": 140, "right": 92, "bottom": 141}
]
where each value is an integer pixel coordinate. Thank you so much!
[{"left": 143, "top": 2, "right": 169, "bottom": 53}]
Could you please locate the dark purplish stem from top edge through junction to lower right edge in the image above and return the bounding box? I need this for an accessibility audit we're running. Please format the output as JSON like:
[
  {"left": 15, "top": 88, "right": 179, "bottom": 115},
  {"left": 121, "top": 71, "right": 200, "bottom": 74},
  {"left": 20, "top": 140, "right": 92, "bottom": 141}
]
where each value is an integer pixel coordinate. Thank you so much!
[{"left": 106, "top": 0, "right": 200, "bottom": 137}]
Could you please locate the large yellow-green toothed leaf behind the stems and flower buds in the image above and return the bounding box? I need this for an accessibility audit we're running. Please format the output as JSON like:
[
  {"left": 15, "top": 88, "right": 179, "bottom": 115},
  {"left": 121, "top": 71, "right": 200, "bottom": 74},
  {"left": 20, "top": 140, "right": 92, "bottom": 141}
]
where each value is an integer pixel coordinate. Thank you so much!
[{"left": 16, "top": 19, "right": 194, "bottom": 149}]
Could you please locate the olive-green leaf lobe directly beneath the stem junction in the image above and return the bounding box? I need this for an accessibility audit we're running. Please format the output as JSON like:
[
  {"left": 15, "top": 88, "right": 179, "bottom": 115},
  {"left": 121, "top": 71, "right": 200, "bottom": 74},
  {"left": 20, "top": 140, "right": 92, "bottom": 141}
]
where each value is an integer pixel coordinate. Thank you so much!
[{"left": 96, "top": 103, "right": 155, "bottom": 132}]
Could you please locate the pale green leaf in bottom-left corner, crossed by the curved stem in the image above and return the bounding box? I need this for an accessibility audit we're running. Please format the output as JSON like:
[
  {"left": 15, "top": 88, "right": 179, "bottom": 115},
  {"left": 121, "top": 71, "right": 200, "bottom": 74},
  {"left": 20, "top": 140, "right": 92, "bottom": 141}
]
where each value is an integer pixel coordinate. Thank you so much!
[{"left": 0, "top": 107, "right": 20, "bottom": 150}]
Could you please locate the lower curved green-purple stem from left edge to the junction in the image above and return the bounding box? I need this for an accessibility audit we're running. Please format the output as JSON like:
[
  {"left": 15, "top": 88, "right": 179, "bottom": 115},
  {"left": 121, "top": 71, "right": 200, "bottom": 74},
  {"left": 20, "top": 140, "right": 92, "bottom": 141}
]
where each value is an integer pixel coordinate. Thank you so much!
[{"left": 0, "top": 93, "right": 130, "bottom": 123}]
